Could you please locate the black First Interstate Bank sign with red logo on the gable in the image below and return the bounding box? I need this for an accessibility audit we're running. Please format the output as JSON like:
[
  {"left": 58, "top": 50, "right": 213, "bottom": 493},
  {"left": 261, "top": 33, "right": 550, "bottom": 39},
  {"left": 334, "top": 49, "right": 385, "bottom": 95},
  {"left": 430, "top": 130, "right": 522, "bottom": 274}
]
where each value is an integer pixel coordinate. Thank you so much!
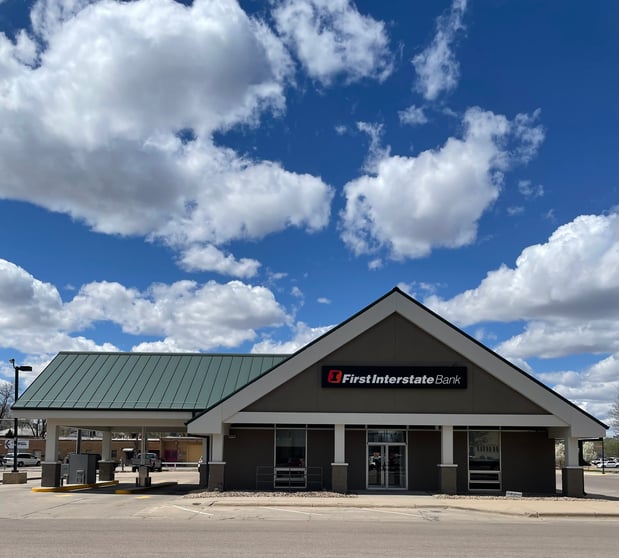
[{"left": 322, "top": 366, "right": 466, "bottom": 389}]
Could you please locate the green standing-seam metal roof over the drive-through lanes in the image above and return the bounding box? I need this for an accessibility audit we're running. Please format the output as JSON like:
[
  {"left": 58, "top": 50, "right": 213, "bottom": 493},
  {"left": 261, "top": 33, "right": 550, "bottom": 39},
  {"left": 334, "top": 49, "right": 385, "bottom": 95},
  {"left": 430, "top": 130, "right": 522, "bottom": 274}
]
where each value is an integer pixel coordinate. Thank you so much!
[{"left": 14, "top": 352, "right": 289, "bottom": 411}]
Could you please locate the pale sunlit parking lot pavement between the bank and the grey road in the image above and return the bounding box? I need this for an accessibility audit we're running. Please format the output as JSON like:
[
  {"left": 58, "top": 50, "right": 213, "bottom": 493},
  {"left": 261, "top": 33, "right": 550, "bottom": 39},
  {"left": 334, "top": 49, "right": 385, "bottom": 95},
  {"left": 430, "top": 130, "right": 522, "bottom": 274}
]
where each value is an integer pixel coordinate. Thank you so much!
[{"left": 0, "top": 467, "right": 619, "bottom": 521}]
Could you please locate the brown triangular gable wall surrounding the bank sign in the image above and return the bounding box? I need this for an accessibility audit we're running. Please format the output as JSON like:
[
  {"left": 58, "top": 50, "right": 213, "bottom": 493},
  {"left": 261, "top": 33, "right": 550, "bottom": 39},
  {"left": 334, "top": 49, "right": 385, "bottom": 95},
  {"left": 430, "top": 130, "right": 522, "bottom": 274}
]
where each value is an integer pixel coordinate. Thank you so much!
[{"left": 244, "top": 313, "right": 547, "bottom": 415}]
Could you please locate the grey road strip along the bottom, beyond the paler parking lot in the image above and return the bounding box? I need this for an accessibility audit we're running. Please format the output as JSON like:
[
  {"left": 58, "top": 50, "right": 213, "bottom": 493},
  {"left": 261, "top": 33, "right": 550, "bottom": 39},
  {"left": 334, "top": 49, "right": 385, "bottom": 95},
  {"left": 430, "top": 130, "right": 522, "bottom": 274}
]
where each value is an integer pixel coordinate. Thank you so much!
[{"left": 0, "top": 520, "right": 619, "bottom": 558}]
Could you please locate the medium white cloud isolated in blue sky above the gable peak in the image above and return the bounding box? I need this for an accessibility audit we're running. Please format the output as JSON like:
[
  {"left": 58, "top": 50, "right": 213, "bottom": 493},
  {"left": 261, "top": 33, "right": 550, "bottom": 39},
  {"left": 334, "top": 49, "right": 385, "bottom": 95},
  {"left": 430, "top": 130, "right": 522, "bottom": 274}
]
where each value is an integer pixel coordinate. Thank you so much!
[{"left": 340, "top": 108, "right": 538, "bottom": 260}]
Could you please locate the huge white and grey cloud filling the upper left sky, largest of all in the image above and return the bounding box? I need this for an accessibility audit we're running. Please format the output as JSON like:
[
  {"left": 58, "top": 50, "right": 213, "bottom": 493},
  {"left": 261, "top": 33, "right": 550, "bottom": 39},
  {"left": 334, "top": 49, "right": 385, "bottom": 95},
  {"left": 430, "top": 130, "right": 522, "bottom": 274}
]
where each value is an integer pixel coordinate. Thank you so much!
[{"left": 0, "top": 0, "right": 333, "bottom": 277}]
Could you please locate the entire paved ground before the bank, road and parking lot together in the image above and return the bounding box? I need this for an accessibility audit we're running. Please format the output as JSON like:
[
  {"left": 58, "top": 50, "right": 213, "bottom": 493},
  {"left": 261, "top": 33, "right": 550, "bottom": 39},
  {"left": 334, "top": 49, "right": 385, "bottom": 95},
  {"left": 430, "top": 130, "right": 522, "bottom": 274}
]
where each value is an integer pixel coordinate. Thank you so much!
[{"left": 0, "top": 469, "right": 619, "bottom": 558}]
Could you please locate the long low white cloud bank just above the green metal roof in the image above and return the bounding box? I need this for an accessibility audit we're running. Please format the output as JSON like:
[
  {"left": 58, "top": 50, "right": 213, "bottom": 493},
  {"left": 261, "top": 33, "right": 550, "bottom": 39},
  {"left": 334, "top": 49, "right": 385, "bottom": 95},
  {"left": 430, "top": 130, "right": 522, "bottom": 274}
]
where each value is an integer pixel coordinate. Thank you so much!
[{"left": 0, "top": 259, "right": 287, "bottom": 355}]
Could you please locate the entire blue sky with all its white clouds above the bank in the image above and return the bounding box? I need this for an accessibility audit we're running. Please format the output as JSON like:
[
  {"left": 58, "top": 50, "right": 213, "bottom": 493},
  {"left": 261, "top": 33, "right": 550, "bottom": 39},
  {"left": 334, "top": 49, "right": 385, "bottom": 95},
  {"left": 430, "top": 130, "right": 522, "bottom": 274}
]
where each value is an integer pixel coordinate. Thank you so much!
[{"left": 0, "top": 0, "right": 619, "bottom": 428}]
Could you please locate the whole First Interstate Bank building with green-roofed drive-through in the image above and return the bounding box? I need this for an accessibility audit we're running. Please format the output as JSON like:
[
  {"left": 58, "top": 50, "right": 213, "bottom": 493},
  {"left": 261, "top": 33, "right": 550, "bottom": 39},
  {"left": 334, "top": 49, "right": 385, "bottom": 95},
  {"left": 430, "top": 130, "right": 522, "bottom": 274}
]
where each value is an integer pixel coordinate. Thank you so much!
[{"left": 14, "top": 288, "right": 607, "bottom": 496}]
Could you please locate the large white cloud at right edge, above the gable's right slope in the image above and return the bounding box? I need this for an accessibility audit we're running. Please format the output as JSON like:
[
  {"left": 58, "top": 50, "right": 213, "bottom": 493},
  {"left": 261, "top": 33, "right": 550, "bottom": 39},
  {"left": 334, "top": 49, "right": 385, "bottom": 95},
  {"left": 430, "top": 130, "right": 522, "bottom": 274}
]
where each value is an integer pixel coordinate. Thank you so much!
[{"left": 425, "top": 212, "right": 619, "bottom": 330}]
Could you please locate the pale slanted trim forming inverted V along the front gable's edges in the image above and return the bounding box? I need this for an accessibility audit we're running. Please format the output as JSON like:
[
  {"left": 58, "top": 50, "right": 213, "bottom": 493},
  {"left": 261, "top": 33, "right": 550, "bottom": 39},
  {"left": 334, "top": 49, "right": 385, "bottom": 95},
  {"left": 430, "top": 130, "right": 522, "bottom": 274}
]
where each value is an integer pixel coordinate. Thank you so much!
[{"left": 187, "top": 289, "right": 606, "bottom": 437}]
